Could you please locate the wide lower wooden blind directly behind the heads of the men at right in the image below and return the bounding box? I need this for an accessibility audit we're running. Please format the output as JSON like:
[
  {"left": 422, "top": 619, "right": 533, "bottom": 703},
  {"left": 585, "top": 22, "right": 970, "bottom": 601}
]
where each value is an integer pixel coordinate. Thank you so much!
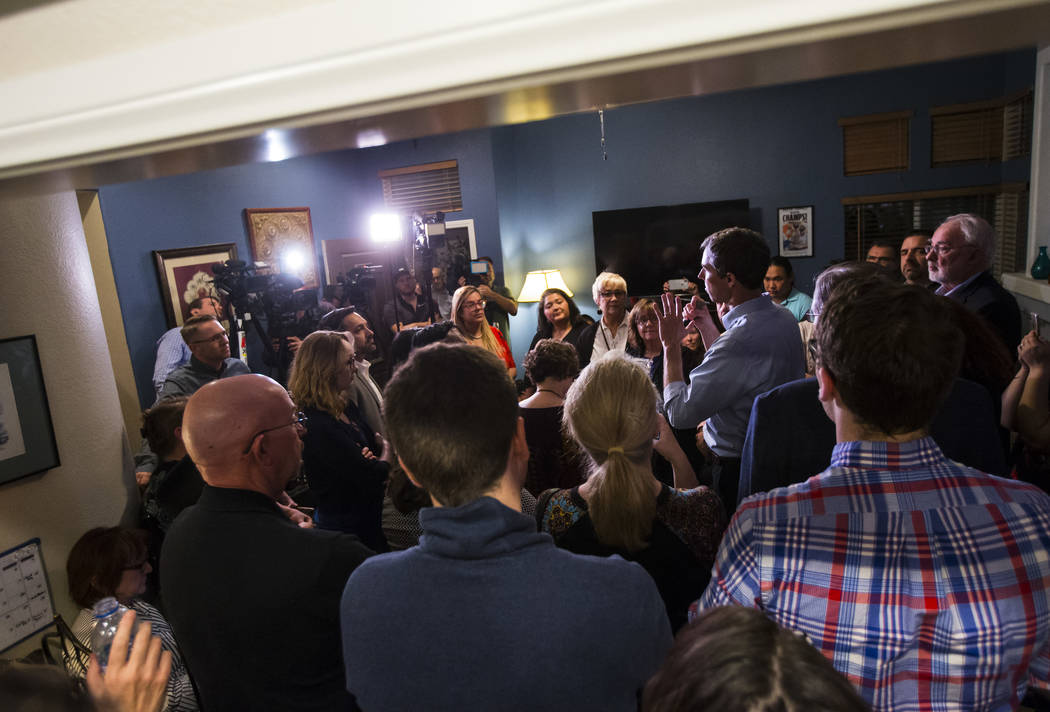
[{"left": 842, "top": 183, "right": 1028, "bottom": 277}]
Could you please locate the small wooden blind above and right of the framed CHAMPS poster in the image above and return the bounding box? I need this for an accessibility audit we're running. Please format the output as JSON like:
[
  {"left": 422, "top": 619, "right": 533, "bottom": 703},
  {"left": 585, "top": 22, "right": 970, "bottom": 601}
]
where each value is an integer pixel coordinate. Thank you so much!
[{"left": 839, "top": 111, "right": 911, "bottom": 175}]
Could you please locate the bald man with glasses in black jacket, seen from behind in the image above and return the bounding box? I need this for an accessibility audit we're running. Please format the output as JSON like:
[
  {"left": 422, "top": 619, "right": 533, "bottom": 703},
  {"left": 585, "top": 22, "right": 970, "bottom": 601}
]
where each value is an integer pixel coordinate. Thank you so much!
[{"left": 161, "top": 374, "right": 372, "bottom": 710}]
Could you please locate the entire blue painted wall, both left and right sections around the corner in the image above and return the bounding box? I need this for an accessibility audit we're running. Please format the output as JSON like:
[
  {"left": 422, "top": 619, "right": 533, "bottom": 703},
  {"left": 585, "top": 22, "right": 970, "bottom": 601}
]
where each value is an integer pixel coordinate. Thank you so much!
[{"left": 100, "top": 50, "right": 1035, "bottom": 404}]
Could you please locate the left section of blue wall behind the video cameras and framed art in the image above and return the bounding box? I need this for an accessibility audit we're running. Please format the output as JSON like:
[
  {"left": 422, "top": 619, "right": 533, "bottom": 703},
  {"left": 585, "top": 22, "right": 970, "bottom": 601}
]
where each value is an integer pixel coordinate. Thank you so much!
[{"left": 99, "top": 131, "right": 501, "bottom": 407}]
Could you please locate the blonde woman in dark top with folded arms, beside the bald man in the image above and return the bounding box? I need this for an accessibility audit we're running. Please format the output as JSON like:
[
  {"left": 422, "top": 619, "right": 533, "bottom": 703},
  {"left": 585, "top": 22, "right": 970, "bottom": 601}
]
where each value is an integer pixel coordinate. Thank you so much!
[{"left": 288, "top": 331, "right": 390, "bottom": 551}]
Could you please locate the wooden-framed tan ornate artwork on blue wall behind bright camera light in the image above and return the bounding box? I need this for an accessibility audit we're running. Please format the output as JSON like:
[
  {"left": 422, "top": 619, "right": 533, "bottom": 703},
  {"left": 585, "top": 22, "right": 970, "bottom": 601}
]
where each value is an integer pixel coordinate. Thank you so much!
[{"left": 245, "top": 208, "right": 321, "bottom": 289}]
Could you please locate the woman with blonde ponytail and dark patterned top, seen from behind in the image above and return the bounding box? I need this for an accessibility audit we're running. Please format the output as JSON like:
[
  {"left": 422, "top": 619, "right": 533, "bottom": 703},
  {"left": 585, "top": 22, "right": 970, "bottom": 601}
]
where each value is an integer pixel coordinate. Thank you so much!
[{"left": 537, "top": 354, "right": 726, "bottom": 630}]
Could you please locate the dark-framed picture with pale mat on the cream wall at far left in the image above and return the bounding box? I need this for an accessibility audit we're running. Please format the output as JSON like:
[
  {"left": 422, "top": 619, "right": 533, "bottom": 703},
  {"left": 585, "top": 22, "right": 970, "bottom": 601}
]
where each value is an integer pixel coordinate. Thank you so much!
[{"left": 0, "top": 335, "right": 61, "bottom": 483}]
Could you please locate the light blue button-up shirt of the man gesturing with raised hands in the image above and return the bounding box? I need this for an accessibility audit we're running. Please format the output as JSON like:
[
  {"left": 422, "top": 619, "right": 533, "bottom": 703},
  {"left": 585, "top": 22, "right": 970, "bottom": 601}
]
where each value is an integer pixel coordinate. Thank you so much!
[{"left": 664, "top": 295, "right": 805, "bottom": 458}]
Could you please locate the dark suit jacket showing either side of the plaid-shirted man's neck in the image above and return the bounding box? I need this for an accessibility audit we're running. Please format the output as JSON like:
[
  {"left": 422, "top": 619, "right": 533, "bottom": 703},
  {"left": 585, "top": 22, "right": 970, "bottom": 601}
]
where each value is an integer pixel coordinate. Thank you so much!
[{"left": 737, "top": 378, "right": 1007, "bottom": 502}]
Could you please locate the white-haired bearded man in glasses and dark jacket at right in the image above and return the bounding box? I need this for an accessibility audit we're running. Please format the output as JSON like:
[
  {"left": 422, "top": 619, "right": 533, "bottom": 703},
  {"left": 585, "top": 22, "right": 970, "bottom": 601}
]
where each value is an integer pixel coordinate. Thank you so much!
[{"left": 926, "top": 213, "right": 1021, "bottom": 356}]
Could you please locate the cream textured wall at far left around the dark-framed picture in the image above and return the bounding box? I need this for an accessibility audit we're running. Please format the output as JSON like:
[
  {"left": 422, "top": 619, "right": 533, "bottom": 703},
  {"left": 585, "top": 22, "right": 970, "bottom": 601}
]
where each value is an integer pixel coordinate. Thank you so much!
[{"left": 0, "top": 187, "right": 133, "bottom": 656}]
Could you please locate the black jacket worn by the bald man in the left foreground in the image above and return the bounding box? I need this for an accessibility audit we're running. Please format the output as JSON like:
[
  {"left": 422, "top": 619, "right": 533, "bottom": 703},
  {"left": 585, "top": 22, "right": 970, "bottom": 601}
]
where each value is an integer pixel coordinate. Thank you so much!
[{"left": 161, "top": 485, "right": 372, "bottom": 712}]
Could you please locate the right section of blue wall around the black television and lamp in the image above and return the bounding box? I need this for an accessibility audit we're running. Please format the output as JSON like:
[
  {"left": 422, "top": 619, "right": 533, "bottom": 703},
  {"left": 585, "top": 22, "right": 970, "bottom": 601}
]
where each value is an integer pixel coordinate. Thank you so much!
[{"left": 492, "top": 50, "right": 1035, "bottom": 360}]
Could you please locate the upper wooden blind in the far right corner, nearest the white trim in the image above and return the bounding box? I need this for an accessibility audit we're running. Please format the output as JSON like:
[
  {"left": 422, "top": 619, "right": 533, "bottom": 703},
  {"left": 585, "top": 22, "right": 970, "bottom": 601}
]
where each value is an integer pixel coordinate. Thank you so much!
[{"left": 929, "top": 91, "right": 1032, "bottom": 166}]
